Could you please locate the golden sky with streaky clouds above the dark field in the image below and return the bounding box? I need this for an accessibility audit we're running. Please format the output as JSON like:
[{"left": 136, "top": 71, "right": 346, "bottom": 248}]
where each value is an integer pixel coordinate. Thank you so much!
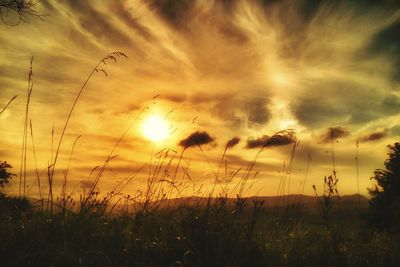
[{"left": 0, "top": 0, "right": 400, "bottom": 200}]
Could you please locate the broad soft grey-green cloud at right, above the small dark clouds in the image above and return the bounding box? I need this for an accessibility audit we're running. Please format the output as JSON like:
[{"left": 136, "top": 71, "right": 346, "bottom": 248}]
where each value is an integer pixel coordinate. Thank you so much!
[{"left": 291, "top": 80, "right": 400, "bottom": 127}]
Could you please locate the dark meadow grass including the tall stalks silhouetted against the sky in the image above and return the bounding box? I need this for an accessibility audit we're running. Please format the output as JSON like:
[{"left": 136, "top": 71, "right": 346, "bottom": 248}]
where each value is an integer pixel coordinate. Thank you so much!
[{"left": 0, "top": 52, "right": 400, "bottom": 267}]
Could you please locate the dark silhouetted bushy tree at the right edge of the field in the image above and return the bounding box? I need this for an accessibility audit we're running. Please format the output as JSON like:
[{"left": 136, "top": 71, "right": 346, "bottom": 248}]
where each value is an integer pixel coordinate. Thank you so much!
[{"left": 369, "top": 143, "right": 400, "bottom": 229}]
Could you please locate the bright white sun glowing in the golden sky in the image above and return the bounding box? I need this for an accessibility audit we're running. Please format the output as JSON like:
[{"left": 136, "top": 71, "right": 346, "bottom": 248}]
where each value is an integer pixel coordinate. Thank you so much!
[{"left": 142, "top": 115, "right": 170, "bottom": 142}]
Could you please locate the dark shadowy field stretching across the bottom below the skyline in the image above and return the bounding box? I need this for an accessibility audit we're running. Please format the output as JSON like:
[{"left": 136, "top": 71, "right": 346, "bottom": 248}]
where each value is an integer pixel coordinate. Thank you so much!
[{"left": 0, "top": 193, "right": 400, "bottom": 266}]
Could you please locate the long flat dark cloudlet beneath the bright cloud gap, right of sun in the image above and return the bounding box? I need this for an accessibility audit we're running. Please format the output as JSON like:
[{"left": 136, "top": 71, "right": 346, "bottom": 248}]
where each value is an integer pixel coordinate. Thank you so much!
[{"left": 246, "top": 130, "right": 297, "bottom": 148}]
